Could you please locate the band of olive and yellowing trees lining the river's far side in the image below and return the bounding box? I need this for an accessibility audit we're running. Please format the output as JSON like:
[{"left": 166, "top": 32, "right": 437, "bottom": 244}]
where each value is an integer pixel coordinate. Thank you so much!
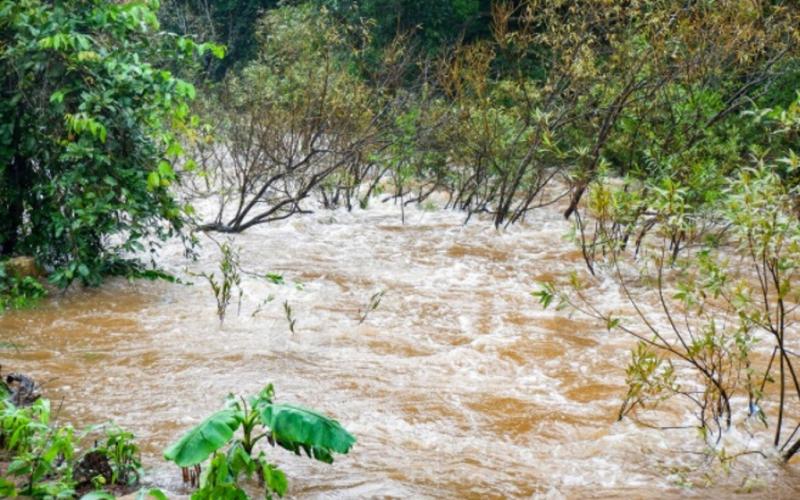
[{"left": 173, "top": 0, "right": 798, "bottom": 231}]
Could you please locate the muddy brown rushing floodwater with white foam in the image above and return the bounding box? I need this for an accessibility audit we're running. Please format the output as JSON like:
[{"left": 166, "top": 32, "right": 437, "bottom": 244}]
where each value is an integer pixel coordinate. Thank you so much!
[{"left": 0, "top": 198, "right": 800, "bottom": 498}]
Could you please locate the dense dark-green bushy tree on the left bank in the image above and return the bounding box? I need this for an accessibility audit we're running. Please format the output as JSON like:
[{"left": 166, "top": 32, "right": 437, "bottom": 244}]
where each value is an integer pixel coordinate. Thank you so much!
[{"left": 0, "top": 0, "right": 219, "bottom": 285}]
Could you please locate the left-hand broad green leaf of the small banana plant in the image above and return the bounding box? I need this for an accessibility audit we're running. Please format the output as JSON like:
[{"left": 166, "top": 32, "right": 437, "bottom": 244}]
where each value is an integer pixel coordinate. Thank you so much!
[{"left": 164, "top": 410, "right": 242, "bottom": 467}]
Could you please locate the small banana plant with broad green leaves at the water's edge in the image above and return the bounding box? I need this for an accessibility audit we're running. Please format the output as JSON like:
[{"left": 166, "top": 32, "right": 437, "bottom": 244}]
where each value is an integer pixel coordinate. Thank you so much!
[{"left": 164, "top": 384, "right": 356, "bottom": 500}]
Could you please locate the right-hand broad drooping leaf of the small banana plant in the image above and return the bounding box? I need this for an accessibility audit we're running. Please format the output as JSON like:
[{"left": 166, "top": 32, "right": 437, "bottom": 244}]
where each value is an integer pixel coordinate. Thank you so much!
[{"left": 261, "top": 404, "right": 356, "bottom": 462}]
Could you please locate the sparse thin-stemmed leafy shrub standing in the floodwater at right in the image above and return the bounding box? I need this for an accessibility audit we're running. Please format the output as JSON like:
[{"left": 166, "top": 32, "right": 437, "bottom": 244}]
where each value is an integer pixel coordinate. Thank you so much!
[{"left": 534, "top": 163, "right": 800, "bottom": 462}]
